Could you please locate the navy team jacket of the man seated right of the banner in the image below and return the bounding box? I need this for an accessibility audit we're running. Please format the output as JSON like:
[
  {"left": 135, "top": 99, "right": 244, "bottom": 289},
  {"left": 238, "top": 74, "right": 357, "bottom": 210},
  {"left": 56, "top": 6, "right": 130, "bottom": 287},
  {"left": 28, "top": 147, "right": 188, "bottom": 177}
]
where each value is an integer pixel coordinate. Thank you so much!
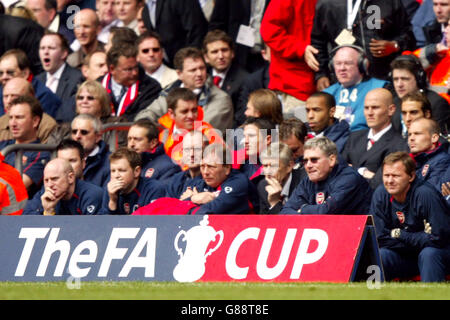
[{"left": 370, "top": 178, "right": 450, "bottom": 253}]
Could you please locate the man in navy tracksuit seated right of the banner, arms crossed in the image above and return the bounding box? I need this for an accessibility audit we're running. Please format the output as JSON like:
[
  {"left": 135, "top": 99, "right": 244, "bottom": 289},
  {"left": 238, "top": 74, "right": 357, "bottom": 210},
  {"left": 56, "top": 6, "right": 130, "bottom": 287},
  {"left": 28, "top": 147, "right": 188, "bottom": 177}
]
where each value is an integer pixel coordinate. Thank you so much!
[{"left": 370, "top": 152, "right": 450, "bottom": 282}]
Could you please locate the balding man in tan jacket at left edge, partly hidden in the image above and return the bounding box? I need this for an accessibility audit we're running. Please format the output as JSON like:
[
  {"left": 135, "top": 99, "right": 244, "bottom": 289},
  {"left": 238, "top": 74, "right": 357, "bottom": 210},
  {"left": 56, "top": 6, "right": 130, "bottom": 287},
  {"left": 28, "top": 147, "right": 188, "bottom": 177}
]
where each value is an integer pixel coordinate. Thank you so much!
[{"left": 0, "top": 78, "right": 57, "bottom": 143}]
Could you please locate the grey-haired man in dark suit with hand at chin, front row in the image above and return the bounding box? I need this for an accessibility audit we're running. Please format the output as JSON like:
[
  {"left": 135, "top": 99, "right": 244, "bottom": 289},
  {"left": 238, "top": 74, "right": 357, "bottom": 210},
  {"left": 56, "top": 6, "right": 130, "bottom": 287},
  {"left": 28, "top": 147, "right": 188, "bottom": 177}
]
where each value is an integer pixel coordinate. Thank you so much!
[{"left": 258, "top": 142, "right": 306, "bottom": 214}]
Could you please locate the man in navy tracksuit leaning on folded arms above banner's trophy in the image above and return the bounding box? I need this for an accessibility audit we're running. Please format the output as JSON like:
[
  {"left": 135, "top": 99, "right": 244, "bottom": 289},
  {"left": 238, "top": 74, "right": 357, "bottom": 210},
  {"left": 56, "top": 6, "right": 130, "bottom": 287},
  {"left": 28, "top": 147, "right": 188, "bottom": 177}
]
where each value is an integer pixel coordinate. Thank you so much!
[{"left": 183, "top": 143, "right": 259, "bottom": 214}]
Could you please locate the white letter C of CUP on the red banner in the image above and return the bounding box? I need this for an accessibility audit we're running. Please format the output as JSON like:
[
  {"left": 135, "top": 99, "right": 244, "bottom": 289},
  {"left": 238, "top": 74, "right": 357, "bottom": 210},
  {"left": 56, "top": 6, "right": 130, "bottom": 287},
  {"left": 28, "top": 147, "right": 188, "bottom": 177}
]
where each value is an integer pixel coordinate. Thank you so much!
[{"left": 225, "top": 228, "right": 260, "bottom": 280}]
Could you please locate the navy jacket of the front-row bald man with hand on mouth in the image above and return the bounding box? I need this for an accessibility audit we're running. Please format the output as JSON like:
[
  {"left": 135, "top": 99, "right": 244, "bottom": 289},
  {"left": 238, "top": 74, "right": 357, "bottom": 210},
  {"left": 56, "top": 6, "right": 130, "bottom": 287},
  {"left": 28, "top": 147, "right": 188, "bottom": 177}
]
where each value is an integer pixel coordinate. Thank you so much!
[{"left": 23, "top": 180, "right": 103, "bottom": 215}]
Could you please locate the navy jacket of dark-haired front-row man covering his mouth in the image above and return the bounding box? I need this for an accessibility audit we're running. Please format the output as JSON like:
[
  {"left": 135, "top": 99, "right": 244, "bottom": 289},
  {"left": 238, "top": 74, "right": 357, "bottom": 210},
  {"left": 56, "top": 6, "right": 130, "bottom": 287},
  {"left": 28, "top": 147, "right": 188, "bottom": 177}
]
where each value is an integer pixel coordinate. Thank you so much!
[{"left": 101, "top": 177, "right": 165, "bottom": 214}]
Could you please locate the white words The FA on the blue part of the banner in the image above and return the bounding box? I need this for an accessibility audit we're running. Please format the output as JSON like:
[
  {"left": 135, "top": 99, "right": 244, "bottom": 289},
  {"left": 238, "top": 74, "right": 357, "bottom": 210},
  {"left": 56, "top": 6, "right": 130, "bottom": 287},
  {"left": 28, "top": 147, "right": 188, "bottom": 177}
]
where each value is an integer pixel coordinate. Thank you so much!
[{"left": 14, "top": 228, "right": 157, "bottom": 278}]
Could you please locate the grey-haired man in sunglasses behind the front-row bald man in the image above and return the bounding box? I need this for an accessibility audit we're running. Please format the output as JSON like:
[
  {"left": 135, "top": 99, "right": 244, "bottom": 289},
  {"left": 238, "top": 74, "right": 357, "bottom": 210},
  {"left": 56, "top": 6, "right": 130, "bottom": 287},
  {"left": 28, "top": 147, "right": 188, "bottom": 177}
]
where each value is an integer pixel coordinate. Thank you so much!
[{"left": 71, "top": 114, "right": 110, "bottom": 186}]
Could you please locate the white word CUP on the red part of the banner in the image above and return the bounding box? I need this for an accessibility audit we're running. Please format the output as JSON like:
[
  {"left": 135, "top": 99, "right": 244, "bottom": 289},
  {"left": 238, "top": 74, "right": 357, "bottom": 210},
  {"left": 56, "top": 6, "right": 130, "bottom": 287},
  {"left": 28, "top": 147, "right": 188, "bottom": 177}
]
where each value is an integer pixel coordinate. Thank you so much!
[{"left": 225, "top": 227, "right": 328, "bottom": 280}]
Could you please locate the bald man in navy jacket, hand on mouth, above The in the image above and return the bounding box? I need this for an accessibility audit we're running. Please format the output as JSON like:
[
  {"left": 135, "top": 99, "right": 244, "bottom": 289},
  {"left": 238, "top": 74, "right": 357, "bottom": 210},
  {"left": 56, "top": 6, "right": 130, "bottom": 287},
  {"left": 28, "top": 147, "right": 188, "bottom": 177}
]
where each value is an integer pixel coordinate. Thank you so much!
[{"left": 23, "top": 158, "right": 103, "bottom": 216}]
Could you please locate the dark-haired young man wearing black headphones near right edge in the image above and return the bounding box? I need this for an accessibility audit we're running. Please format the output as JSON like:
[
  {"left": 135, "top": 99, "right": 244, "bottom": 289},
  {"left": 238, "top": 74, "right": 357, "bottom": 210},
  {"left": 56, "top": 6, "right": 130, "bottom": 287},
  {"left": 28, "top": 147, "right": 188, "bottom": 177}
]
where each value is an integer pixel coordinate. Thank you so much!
[{"left": 390, "top": 55, "right": 450, "bottom": 135}]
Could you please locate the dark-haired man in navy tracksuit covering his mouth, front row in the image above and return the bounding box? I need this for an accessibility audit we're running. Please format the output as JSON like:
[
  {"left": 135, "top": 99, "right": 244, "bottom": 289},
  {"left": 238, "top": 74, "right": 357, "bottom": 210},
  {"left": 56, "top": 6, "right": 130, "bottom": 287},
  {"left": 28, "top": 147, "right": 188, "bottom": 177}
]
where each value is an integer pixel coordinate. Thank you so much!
[{"left": 101, "top": 147, "right": 165, "bottom": 214}]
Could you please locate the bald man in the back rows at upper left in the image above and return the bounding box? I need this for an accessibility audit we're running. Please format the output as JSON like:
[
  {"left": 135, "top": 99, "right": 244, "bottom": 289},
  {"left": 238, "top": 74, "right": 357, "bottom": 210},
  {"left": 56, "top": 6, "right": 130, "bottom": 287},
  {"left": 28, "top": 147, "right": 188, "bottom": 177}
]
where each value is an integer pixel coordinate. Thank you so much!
[{"left": 67, "top": 9, "right": 104, "bottom": 68}]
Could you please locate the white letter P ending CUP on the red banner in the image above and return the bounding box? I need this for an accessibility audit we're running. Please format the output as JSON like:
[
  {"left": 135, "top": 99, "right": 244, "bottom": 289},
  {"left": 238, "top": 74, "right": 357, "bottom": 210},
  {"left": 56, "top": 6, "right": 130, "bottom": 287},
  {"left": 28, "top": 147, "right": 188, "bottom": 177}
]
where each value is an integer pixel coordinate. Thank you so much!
[{"left": 291, "top": 229, "right": 328, "bottom": 279}]
